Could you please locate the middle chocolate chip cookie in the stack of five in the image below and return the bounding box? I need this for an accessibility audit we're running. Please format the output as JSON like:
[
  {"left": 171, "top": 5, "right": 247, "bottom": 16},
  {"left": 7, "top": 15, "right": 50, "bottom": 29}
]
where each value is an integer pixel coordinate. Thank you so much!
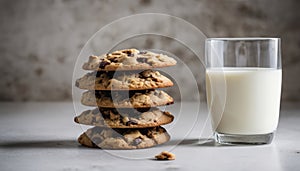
[{"left": 81, "top": 90, "right": 174, "bottom": 108}]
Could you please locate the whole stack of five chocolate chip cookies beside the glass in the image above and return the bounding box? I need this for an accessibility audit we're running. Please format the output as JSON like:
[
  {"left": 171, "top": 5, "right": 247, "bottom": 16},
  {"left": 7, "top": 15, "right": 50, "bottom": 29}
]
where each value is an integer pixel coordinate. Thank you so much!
[{"left": 74, "top": 49, "right": 176, "bottom": 149}]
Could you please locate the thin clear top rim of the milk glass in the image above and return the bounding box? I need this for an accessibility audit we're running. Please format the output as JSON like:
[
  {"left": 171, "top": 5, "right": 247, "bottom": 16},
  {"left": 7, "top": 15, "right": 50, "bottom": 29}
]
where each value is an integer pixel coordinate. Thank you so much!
[{"left": 206, "top": 37, "right": 280, "bottom": 41}]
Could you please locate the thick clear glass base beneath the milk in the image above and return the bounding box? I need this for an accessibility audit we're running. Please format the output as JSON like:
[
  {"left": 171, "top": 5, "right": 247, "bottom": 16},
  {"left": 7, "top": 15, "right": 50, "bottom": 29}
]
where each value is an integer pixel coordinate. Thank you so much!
[{"left": 215, "top": 132, "right": 274, "bottom": 145}]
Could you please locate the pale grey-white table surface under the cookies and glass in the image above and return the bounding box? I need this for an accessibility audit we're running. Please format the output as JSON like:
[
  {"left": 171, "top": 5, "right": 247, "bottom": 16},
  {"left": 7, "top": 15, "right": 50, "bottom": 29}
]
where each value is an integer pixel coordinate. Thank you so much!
[{"left": 0, "top": 102, "right": 300, "bottom": 171}]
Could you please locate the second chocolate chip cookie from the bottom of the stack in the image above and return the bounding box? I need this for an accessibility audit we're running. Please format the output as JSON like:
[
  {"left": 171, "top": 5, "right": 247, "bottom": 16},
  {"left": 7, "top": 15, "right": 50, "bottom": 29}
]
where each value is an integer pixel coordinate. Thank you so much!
[{"left": 74, "top": 108, "right": 174, "bottom": 128}]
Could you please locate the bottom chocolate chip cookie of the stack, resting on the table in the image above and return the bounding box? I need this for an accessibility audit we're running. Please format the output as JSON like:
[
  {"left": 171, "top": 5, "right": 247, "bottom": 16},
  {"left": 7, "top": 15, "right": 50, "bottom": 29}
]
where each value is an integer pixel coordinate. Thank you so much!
[{"left": 78, "top": 127, "right": 170, "bottom": 149}]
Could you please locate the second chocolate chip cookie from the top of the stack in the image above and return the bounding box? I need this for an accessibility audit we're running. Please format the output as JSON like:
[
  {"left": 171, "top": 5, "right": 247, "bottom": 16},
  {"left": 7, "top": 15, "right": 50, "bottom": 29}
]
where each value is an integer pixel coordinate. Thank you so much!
[{"left": 75, "top": 70, "right": 173, "bottom": 90}]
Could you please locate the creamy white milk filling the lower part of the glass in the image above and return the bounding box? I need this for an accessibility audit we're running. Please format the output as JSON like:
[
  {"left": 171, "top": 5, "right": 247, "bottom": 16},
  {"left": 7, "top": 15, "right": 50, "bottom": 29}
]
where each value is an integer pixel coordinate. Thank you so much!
[{"left": 206, "top": 67, "right": 282, "bottom": 135}]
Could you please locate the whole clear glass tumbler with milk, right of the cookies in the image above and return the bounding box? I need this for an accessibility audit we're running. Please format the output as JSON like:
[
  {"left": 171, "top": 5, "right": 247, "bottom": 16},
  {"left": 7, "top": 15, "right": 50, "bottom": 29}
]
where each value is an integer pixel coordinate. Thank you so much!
[{"left": 205, "top": 38, "right": 282, "bottom": 144}]
